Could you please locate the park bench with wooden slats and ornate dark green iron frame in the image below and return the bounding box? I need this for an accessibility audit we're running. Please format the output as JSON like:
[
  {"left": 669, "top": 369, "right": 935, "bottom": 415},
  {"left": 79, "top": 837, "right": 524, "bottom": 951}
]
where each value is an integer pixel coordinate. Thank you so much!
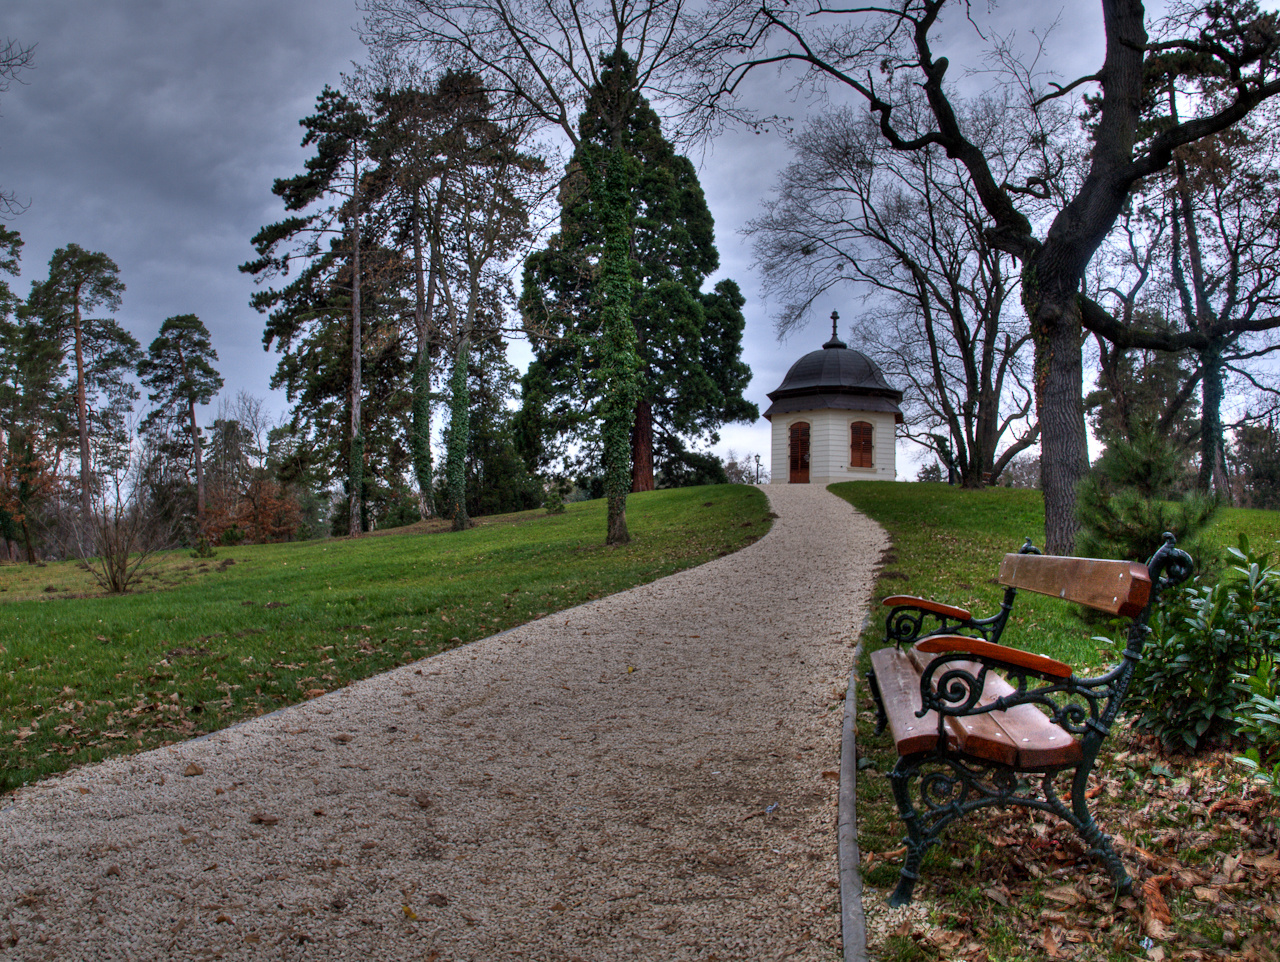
[{"left": 868, "top": 535, "right": 1193, "bottom": 906}]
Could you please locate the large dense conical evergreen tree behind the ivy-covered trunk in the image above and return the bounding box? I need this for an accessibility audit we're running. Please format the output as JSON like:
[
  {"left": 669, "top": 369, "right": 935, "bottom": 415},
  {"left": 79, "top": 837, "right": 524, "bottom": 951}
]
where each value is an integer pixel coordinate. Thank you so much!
[{"left": 517, "top": 52, "right": 758, "bottom": 491}]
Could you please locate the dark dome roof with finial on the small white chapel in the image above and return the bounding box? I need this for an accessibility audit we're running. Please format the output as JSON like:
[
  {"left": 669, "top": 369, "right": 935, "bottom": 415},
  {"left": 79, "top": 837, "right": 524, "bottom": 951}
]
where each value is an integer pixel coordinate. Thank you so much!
[{"left": 764, "top": 334, "right": 902, "bottom": 420}]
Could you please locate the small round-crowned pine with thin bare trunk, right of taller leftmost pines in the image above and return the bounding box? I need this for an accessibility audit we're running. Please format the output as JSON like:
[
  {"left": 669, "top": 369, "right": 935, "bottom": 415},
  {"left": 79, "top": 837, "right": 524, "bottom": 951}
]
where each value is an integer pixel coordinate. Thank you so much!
[{"left": 138, "top": 313, "right": 223, "bottom": 530}]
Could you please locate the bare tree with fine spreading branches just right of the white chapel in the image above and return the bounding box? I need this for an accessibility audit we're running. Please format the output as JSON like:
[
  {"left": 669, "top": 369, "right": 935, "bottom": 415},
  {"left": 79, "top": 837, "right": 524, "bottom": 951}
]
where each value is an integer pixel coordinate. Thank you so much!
[{"left": 746, "top": 104, "right": 1038, "bottom": 487}]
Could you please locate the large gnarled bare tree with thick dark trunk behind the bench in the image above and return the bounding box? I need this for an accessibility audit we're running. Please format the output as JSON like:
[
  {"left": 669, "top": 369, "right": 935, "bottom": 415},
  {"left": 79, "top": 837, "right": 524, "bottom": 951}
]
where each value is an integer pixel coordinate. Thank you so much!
[{"left": 713, "top": 0, "right": 1280, "bottom": 553}]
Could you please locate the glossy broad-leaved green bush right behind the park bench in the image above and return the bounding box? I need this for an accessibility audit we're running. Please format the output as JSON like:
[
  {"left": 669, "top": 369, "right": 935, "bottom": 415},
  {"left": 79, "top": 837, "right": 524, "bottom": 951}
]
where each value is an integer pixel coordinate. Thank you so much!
[{"left": 1125, "top": 535, "right": 1280, "bottom": 751}]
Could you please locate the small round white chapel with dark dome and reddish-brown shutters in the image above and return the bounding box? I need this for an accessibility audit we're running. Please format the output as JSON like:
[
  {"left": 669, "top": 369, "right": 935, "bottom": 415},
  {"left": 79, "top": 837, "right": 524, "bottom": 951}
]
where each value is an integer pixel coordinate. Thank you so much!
[{"left": 764, "top": 311, "right": 902, "bottom": 485}]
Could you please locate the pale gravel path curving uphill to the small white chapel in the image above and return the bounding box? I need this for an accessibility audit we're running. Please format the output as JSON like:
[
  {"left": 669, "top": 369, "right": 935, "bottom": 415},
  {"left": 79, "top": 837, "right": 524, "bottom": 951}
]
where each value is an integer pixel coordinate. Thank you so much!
[{"left": 0, "top": 485, "right": 887, "bottom": 962}]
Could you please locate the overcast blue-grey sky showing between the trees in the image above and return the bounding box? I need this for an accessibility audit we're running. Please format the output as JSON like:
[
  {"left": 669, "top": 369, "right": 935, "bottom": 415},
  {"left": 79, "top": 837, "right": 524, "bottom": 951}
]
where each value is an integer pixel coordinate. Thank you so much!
[{"left": 0, "top": 0, "right": 1101, "bottom": 477}]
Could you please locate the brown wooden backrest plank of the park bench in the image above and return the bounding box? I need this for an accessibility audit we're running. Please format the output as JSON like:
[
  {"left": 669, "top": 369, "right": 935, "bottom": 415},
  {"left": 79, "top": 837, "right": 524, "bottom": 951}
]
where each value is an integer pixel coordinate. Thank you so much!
[{"left": 1000, "top": 554, "right": 1151, "bottom": 618}]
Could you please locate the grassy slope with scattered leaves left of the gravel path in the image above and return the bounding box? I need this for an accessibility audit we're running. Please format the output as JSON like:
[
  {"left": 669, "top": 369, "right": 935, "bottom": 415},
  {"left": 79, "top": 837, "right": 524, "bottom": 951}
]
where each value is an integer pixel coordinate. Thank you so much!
[{"left": 0, "top": 485, "right": 769, "bottom": 791}]
